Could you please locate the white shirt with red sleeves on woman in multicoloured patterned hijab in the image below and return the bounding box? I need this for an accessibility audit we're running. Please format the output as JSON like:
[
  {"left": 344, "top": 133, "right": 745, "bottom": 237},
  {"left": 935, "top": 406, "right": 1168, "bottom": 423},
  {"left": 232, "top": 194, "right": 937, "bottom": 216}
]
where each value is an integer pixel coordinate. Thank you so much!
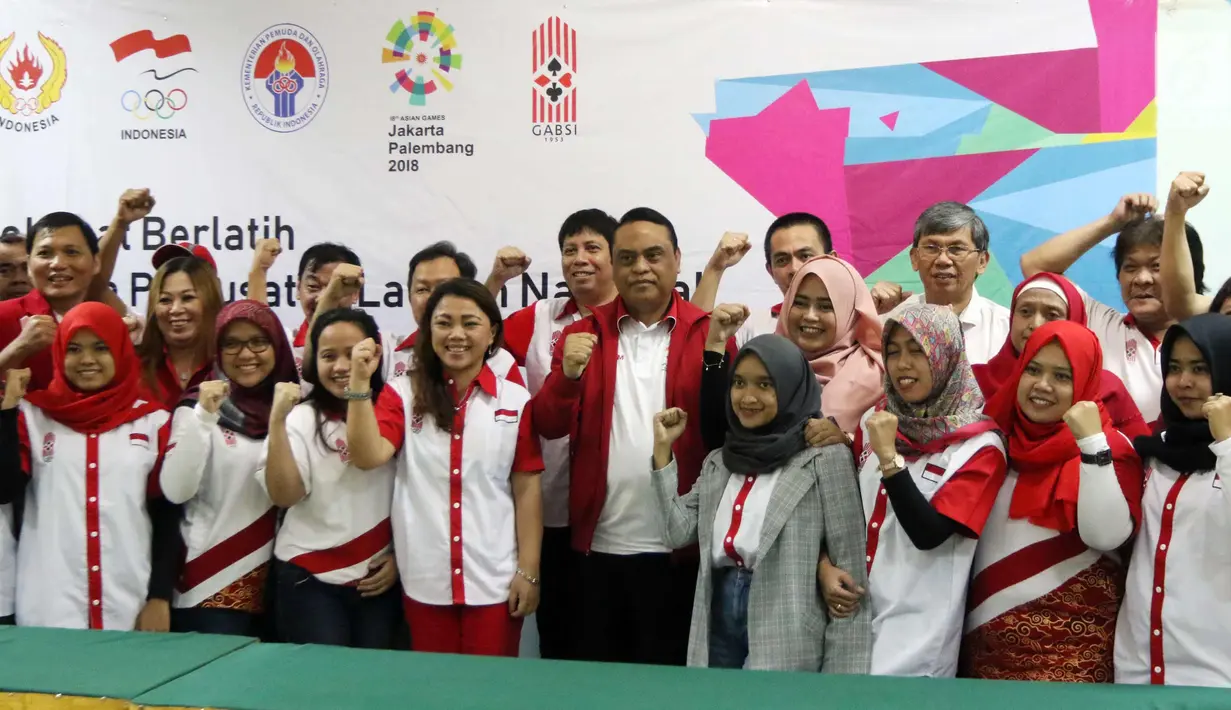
[{"left": 854, "top": 410, "right": 1004, "bottom": 678}]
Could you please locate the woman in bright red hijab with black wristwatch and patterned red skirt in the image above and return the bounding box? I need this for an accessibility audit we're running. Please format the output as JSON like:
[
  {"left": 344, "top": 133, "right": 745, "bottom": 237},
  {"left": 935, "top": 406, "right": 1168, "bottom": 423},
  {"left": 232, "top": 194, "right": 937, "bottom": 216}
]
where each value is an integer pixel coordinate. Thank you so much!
[{"left": 961, "top": 321, "right": 1142, "bottom": 683}]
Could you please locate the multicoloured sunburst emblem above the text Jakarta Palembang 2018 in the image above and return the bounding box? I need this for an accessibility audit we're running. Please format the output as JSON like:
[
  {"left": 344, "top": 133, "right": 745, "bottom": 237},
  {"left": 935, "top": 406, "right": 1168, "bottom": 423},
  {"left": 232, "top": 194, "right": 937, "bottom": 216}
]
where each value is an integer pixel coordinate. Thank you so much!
[{"left": 380, "top": 10, "right": 462, "bottom": 106}]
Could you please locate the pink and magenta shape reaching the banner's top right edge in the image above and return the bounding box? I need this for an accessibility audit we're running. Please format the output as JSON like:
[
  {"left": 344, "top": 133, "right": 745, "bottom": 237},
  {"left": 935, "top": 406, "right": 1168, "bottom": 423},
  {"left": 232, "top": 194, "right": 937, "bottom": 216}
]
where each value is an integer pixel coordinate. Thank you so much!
[{"left": 923, "top": 0, "right": 1158, "bottom": 133}]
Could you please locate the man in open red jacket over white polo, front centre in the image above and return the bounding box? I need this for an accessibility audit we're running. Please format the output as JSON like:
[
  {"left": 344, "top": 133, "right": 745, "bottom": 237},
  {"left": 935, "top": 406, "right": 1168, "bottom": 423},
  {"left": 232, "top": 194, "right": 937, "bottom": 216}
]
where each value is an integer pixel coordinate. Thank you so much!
[{"left": 532, "top": 208, "right": 734, "bottom": 664}]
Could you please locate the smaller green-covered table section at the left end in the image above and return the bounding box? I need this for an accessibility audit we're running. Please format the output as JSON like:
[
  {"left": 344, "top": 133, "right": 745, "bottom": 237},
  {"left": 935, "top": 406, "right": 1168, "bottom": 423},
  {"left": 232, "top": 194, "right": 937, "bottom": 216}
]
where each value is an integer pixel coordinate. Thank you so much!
[{"left": 0, "top": 626, "right": 252, "bottom": 700}]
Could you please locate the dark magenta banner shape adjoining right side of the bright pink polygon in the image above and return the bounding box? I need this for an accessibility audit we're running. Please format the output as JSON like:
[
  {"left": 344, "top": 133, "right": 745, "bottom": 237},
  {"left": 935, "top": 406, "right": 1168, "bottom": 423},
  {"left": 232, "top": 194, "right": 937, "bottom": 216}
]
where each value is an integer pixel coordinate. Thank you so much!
[{"left": 846, "top": 149, "right": 1045, "bottom": 274}]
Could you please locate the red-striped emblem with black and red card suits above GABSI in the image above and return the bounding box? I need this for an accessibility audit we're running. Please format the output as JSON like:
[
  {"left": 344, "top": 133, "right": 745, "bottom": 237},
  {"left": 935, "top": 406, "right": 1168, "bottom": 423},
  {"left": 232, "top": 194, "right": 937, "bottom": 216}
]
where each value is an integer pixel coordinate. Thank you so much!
[{"left": 531, "top": 17, "right": 577, "bottom": 126}]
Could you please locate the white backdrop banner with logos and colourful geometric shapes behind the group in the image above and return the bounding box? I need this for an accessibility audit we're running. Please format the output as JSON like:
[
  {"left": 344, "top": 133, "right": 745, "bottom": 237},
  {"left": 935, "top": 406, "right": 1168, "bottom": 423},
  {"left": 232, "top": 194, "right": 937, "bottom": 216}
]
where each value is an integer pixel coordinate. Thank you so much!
[{"left": 0, "top": 0, "right": 1231, "bottom": 332}]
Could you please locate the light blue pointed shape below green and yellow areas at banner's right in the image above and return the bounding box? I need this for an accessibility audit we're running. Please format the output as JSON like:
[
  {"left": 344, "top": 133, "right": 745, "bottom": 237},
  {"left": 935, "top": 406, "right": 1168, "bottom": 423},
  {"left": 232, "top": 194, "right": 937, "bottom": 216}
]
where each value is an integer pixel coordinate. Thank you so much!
[{"left": 970, "top": 159, "right": 1156, "bottom": 233}]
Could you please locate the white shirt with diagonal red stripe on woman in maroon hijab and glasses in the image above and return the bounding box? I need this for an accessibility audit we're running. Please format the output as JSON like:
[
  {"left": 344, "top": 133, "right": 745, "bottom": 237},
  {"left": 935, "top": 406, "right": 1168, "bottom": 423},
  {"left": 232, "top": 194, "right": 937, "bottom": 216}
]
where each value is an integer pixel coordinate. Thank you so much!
[{"left": 160, "top": 404, "right": 277, "bottom": 609}]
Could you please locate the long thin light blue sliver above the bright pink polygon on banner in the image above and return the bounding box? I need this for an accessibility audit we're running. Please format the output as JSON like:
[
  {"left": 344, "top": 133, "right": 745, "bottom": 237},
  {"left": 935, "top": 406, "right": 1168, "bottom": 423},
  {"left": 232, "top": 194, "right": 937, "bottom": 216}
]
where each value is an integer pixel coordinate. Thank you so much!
[{"left": 732, "top": 64, "right": 987, "bottom": 101}]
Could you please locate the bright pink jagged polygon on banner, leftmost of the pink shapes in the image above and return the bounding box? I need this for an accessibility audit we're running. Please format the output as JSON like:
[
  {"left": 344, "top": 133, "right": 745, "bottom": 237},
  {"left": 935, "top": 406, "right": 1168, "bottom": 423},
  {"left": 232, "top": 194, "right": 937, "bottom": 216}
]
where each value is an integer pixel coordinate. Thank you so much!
[{"left": 705, "top": 81, "right": 851, "bottom": 255}]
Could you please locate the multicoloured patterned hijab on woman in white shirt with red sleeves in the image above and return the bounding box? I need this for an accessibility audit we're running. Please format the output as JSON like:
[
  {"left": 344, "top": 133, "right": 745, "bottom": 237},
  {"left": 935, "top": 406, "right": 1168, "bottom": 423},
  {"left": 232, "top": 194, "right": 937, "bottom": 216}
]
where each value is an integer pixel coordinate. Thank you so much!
[{"left": 883, "top": 304, "right": 996, "bottom": 455}]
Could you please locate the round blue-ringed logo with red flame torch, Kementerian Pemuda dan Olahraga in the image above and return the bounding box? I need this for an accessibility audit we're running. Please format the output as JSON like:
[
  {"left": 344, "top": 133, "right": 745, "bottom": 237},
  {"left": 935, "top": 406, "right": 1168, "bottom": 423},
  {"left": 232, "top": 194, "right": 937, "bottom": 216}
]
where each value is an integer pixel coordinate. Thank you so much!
[{"left": 241, "top": 23, "right": 329, "bottom": 133}]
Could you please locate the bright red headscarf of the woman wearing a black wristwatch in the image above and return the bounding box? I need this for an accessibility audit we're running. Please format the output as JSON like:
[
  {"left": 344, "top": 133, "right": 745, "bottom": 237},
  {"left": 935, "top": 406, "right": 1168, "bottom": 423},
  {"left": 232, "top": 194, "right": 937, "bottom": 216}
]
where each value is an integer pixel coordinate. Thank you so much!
[{"left": 985, "top": 320, "right": 1141, "bottom": 533}]
